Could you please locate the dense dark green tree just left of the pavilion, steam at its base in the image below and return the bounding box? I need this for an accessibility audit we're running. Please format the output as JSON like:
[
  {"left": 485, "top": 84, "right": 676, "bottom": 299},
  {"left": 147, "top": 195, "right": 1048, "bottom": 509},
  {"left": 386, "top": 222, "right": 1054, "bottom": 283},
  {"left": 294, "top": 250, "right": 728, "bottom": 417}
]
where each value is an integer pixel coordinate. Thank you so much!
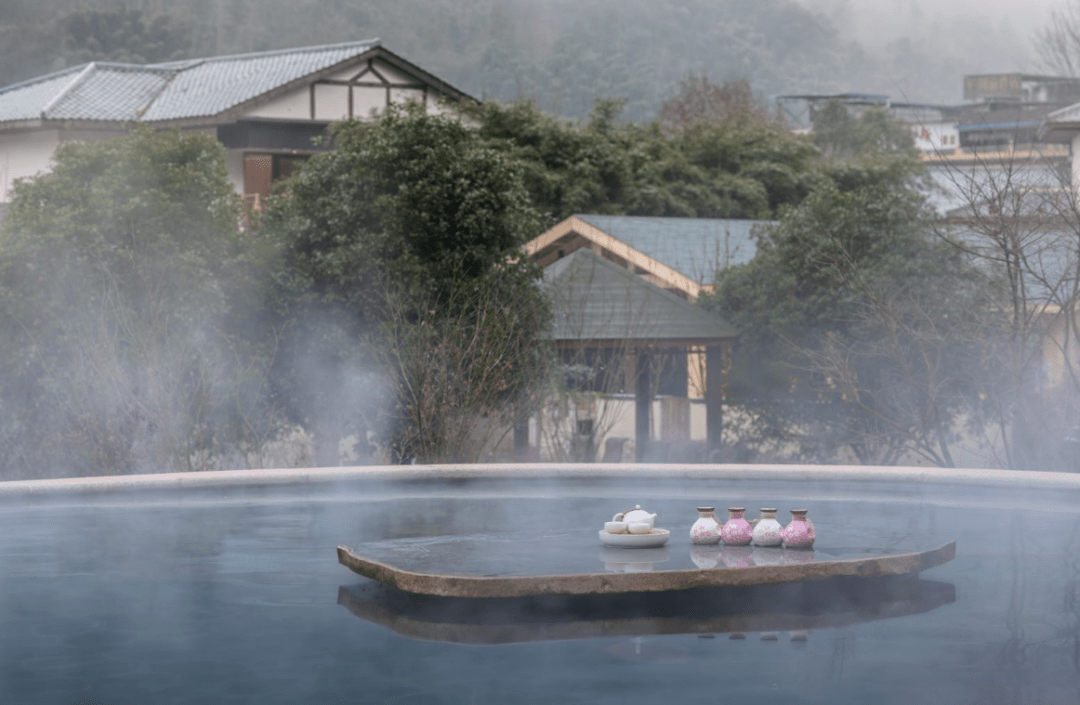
[{"left": 266, "top": 105, "right": 544, "bottom": 465}]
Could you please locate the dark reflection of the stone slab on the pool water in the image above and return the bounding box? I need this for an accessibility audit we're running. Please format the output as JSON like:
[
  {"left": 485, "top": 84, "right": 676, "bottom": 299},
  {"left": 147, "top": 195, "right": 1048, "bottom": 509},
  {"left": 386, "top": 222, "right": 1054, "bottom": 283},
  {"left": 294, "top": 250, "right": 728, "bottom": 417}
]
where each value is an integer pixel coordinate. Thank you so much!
[{"left": 338, "top": 578, "right": 956, "bottom": 645}]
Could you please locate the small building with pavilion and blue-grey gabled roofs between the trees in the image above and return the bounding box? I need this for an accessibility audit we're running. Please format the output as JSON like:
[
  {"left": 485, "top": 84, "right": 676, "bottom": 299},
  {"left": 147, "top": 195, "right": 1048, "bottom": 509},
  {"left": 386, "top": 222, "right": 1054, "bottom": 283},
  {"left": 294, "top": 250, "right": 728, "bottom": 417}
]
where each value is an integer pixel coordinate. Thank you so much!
[{"left": 525, "top": 215, "right": 751, "bottom": 462}]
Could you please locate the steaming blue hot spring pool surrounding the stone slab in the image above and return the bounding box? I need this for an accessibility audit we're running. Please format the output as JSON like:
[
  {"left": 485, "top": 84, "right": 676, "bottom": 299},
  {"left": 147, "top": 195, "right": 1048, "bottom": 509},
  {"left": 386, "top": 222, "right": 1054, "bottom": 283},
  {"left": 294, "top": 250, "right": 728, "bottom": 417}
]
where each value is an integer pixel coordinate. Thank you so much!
[{"left": 0, "top": 465, "right": 1080, "bottom": 705}]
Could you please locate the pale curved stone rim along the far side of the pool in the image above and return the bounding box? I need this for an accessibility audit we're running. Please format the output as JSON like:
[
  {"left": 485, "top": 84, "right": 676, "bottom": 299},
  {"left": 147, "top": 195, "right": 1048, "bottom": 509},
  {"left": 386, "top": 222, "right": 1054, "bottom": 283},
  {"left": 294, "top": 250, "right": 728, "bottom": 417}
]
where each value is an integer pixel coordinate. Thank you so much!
[{"left": 0, "top": 463, "right": 1080, "bottom": 499}]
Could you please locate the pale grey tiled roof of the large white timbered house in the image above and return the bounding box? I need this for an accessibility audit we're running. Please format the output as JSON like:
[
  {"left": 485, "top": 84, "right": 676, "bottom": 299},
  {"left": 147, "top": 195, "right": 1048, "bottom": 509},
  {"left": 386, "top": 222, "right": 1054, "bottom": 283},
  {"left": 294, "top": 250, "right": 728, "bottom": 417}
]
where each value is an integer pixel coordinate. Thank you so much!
[{"left": 0, "top": 39, "right": 379, "bottom": 122}]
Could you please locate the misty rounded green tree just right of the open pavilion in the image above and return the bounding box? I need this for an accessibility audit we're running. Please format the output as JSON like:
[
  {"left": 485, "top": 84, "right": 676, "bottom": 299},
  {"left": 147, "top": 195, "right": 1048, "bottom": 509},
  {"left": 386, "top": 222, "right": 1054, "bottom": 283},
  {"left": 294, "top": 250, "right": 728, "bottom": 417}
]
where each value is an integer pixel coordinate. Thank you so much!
[{"left": 705, "top": 159, "right": 985, "bottom": 465}]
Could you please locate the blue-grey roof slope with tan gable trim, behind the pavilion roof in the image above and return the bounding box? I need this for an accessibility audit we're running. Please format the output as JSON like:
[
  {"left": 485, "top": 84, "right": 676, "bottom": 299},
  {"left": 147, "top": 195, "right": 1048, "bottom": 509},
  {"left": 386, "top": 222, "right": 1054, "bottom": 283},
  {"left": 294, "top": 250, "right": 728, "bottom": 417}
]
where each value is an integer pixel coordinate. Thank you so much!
[{"left": 577, "top": 215, "right": 771, "bottom": 286}]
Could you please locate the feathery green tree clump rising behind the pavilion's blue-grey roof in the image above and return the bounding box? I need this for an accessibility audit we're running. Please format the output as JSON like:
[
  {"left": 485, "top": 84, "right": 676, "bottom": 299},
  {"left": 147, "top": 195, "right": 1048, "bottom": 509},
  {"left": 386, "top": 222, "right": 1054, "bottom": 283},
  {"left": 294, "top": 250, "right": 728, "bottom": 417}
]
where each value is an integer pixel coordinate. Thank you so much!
[{"left": 477, "top": 101, "right": 819, "bottom": 225}]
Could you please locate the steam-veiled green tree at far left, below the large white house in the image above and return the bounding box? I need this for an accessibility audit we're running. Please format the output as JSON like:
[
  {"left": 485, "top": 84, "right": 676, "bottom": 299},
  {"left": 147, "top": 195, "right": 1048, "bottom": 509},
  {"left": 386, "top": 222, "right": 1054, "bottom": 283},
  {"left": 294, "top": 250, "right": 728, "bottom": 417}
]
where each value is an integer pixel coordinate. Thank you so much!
[{"left": 0, "top": 130, "right": 273, "bottom": 477}]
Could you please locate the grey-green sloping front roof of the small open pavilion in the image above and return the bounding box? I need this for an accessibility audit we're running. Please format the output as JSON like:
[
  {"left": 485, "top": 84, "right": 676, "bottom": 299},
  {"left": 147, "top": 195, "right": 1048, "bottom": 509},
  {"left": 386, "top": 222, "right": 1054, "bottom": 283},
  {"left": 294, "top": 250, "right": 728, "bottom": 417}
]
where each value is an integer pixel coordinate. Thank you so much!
[{"left": 544, "top": 249, "right": 738, "bottom": 341}]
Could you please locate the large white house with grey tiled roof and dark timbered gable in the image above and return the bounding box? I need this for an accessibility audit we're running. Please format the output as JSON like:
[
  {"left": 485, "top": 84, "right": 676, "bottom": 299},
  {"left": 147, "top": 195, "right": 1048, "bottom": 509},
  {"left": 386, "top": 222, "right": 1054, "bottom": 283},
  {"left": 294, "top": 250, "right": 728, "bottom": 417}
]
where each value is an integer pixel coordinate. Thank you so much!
[{"left": 0, "top": 39, "right": 475, "bottom": 204}]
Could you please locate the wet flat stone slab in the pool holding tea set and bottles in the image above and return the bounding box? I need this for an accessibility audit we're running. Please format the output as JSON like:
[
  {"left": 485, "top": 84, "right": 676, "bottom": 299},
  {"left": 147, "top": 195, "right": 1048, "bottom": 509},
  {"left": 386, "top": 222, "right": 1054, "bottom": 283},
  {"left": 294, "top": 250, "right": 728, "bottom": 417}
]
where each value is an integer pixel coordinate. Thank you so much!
[{"left": 337, "top": 527, "right": 956, "bottom": 598}]
